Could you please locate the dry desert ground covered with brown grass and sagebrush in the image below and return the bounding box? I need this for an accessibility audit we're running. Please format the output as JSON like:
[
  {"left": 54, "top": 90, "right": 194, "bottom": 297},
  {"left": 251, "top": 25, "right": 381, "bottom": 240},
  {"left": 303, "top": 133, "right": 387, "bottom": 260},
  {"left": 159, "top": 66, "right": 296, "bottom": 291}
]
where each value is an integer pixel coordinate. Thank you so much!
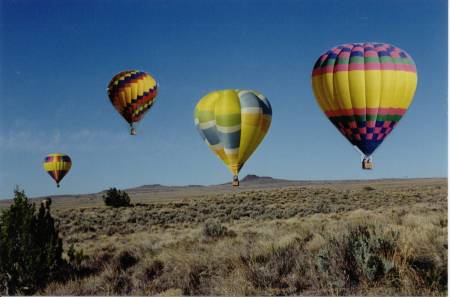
[{"left": 1, "top": 176, "right": 448, "bottom": 295}]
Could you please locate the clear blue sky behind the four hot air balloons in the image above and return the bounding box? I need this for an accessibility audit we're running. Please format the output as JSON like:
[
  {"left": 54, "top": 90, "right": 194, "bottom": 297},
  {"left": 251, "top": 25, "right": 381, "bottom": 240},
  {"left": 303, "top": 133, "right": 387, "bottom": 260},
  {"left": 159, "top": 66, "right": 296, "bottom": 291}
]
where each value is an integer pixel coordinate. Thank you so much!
[{"left": 0, "top": 0, "right": 448, "bottom": 198}]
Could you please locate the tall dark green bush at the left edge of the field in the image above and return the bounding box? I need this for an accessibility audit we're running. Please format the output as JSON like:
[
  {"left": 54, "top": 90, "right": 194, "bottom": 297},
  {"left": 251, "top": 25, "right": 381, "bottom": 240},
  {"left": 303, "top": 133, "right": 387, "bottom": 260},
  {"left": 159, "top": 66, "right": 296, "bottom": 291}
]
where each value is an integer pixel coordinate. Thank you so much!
[{"left": 0, "top": 188, "right": 68, "bottom": 295}]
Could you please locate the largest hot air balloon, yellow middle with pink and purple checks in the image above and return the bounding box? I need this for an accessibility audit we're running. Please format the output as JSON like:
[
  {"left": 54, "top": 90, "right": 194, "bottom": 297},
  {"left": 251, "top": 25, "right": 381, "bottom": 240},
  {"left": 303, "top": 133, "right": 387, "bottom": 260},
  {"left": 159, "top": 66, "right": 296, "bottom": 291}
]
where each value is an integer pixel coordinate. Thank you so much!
[{"left": 312, "top": 43, "right": 417, "bottom": 169}]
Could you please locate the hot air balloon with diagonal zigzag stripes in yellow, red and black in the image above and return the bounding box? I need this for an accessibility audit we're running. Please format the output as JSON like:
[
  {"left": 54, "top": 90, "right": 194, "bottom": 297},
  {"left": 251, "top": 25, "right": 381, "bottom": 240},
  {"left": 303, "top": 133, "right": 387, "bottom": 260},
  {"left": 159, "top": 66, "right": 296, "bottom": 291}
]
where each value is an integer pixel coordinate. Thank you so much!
[{"left": 108, "top": 70, "right": 158, "bottom": 135}]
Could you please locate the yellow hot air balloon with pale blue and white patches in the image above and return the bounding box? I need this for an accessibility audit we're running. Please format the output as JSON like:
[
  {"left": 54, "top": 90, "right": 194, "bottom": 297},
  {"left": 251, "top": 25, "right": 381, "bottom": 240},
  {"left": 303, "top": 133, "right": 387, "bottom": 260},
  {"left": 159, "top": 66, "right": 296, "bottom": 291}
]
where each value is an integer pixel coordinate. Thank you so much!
[{"left": 194, "top": 90, "right": 272, "bottom": 186}]
